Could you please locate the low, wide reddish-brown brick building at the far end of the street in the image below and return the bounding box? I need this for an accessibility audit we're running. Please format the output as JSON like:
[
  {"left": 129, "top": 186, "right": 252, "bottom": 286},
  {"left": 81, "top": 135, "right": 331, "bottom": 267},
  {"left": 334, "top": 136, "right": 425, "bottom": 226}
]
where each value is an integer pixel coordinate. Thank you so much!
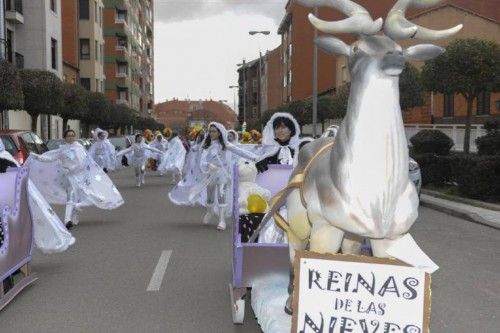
[{"left": 153, "top": 99, "right": 237, "bottom": 134}]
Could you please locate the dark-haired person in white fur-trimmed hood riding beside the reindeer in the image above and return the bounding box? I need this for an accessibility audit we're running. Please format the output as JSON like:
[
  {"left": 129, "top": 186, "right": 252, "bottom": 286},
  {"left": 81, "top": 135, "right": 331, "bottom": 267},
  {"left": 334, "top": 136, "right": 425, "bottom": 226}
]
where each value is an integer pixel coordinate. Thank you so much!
[{"left": 256, "top": 112, "right": 301, "bottom": 172}]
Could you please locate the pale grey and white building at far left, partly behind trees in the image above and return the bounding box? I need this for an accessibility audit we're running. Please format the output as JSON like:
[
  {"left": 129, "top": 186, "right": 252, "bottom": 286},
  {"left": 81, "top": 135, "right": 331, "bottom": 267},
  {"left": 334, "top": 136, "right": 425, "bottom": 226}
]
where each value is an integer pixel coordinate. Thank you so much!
[{"left": 3, "top": 0, "right": 79, "bottom": 140}]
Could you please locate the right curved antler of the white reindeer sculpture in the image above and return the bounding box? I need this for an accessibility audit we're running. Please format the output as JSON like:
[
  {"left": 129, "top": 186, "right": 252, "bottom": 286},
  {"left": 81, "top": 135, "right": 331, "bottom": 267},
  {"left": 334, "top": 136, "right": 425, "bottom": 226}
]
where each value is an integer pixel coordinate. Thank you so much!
[{"left": 384, "top": 0, "right": 463, "bottom": 40}]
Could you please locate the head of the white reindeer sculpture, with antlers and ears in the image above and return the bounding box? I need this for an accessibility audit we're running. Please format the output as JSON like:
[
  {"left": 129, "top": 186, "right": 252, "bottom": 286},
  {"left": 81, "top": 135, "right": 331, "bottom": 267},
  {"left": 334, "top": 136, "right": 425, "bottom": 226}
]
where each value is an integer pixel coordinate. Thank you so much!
[{"left": 295, "top": 0, "right": 462, "bottom": 77}]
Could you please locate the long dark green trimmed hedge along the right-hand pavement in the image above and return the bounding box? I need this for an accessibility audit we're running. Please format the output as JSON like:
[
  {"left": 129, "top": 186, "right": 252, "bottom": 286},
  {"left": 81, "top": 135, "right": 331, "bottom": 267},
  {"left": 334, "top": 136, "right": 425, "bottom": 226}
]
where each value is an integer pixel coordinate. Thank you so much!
[{"left": 413, "top": 154, "right": 500, "bottom": 202}]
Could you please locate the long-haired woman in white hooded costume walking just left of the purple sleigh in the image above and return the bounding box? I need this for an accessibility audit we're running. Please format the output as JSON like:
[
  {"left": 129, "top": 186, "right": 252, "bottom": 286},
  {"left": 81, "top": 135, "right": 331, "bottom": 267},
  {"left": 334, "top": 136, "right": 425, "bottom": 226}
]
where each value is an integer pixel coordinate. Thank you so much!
[{"left": 170, "top": 122, "right": 257, "bottom": 230}]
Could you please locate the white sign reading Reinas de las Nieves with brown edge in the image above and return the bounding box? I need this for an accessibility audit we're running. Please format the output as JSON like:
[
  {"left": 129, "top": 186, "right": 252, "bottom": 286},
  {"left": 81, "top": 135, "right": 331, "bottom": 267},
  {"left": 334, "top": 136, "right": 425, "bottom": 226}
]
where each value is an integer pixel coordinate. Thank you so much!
[{"left": 292, "top": 252, "right": 431, "bottom": 333}]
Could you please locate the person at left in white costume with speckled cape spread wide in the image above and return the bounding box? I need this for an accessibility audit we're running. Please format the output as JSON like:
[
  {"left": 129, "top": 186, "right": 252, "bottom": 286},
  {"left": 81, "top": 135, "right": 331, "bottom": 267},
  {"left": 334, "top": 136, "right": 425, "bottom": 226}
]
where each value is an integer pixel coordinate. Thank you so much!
[{"left": 27, "top": 130, "right": 123, "bottom": 229}]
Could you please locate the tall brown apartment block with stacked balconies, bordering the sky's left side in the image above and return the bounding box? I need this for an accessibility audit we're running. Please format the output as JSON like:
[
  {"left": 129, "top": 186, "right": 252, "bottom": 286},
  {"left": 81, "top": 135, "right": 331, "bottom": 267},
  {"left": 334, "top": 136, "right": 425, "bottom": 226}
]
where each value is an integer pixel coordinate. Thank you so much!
[{"left": 103, "top": 0, "right": 154, "bottom": 115}]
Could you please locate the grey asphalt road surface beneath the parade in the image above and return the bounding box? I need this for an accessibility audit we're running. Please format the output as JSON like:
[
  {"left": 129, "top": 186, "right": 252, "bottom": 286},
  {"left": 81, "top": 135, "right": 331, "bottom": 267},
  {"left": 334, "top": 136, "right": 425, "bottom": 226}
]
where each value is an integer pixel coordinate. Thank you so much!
[{"left": 0, "top": 170, "right": 500, "bottom": 333}]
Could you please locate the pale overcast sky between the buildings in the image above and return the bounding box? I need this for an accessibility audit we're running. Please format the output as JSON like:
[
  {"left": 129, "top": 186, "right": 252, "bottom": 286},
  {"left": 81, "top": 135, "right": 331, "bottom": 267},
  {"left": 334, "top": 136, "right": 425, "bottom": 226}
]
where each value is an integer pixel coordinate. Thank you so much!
[{"left": 154, "top": 0, "right": 287, "bottom": 111}]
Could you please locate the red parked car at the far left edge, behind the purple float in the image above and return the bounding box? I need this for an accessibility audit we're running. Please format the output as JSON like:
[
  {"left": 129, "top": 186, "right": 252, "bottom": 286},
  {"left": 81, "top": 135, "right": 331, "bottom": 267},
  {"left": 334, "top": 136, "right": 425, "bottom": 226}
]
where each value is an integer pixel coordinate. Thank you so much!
[{"left": 0, "top": 130, "right": 49, "bottom": 165}]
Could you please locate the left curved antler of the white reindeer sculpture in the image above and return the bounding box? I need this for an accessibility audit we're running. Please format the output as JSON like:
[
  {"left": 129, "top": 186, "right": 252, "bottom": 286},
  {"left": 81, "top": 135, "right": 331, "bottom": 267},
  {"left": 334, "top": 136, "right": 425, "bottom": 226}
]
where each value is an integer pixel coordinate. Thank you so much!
[{"left": 295, "top": 0, "right": 383, "bottom": 35}]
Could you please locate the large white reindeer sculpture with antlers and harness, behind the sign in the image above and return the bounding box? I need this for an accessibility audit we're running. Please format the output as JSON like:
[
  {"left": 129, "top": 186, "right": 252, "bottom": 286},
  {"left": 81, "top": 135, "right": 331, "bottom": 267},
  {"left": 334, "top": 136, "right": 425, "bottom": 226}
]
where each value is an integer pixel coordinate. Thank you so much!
[{"left": 260, "top": 0, "right": 462, "bottom": 313}]
